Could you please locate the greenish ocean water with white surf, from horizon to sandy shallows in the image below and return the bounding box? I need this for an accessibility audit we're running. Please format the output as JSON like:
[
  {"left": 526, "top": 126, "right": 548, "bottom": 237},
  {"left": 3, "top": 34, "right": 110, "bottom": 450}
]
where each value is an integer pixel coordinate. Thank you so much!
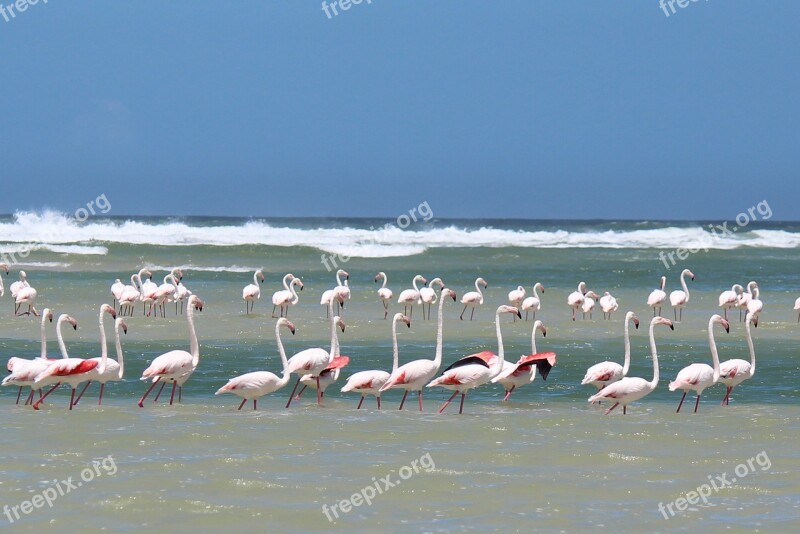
[{"left": 0, "top": 211, "right": 800, "bottom": 532}]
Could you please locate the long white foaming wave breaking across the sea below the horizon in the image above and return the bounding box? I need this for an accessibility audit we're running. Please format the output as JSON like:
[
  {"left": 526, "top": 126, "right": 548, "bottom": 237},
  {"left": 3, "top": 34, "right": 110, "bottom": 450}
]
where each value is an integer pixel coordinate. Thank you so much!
[{"left": 0, "top": 211, "right": 800, "bottom": 258}]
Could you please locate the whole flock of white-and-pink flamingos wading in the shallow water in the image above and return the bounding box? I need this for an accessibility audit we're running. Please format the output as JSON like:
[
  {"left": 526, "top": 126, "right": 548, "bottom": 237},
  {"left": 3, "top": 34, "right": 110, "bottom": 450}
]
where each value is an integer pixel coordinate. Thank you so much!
[{"left": 0, "top": 264, "right": 784, "bottom": 414}]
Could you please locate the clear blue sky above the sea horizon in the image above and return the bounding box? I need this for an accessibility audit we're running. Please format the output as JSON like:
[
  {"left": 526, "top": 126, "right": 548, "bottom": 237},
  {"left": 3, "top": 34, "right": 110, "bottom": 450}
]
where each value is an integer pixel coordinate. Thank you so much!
[{"left": 0, "top": 0, "right": 800, "bottom": 220}]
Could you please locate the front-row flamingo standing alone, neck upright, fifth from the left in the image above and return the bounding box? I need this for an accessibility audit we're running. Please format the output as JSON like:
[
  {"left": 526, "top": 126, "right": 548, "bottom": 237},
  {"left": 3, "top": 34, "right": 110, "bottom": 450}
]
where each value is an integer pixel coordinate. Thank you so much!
[{"left": 138, "top": 295, "right": 203, "bottom": 408}]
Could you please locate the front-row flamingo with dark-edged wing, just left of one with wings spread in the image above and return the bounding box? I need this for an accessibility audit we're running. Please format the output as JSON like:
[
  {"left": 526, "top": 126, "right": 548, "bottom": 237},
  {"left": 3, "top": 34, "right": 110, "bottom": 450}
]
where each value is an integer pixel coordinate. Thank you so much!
[{"left": 427, "top": 304, "right": 522, "bottom": 414}]
